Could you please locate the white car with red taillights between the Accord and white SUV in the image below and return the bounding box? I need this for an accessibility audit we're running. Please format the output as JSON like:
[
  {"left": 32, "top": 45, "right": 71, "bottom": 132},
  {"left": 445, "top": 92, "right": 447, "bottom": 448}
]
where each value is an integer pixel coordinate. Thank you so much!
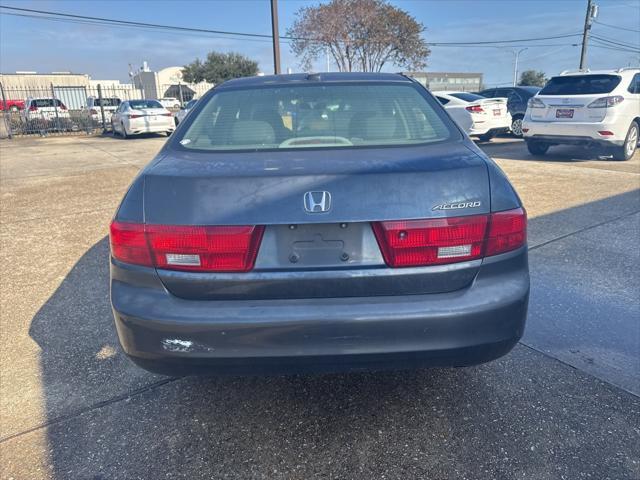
[{"left": 434, "top": 92, "right": 511, "bottom": 142}]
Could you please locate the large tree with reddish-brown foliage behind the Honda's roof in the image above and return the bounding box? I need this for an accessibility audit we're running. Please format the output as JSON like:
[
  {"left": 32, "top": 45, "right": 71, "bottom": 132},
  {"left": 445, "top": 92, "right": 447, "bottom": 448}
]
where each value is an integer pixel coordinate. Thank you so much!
[{"left": 287, "top": 0, "right": 431, "bottom": 72}]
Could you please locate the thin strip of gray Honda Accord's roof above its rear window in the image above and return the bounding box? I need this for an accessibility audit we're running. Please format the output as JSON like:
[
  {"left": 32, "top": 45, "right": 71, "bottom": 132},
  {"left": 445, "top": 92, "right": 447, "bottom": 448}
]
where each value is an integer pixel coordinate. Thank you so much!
[{"left": 216, "top": 72, "right": 413, "bottom": 88}]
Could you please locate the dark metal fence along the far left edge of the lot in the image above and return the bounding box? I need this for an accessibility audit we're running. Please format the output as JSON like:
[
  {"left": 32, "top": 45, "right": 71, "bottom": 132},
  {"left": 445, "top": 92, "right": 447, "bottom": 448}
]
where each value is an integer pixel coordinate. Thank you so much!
[{"left": 0, "top": 83, "right": 198, "bottom": 137}]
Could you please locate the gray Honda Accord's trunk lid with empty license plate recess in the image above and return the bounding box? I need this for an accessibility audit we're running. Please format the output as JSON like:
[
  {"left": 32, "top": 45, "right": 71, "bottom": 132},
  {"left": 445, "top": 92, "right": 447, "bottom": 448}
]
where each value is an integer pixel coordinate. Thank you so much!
[{"left": 144, "top": 142, "right": 490, "bottom": 299}]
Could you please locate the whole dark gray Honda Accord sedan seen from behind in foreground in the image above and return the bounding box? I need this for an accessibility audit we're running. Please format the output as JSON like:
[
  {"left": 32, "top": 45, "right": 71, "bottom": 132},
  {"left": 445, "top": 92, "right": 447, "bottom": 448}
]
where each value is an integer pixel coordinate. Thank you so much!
[{"left": 110, "top": 73, "right": 529, "bottom": 374}]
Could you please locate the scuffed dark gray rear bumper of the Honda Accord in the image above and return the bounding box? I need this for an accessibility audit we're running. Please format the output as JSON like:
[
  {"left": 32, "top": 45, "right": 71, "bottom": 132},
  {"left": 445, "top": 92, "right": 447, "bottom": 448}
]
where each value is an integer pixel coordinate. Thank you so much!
[{"left": 111, "top": 248, "right": 529, "bottom": 374}]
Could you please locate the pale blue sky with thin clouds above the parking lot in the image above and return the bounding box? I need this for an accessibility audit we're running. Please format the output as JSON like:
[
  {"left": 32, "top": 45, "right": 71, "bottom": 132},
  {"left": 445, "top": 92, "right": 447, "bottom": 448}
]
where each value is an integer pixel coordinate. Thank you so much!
[{"left": 0, "top": 0, "right": 640, "bottom": 85}]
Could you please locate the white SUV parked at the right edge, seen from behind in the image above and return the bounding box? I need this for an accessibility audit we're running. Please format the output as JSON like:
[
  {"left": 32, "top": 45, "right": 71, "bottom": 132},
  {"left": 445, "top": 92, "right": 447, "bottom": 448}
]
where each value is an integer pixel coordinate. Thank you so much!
[{"left": 522, "top": 68, "right": 640, "bottom": 160}]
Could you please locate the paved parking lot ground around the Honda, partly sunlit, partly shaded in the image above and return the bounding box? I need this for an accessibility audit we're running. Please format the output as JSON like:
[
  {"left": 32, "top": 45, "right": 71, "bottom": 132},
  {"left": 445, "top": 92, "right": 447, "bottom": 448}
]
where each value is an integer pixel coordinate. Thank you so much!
[{"left": 0, "top": 136, "right": 640, "bottom": 480}]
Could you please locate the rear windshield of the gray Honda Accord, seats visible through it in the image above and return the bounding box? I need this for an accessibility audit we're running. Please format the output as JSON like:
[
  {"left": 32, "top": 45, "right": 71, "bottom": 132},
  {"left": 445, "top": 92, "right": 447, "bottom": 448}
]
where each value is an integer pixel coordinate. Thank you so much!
[{"left": 179, "top": 84, "right": 455, "bottom": 150}]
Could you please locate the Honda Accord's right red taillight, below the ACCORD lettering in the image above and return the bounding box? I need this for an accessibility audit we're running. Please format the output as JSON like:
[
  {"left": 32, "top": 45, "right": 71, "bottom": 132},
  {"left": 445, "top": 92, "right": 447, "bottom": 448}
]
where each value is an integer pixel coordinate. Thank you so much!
[{"left": 372, "top": 208, "right": 527, "bottom": 267}]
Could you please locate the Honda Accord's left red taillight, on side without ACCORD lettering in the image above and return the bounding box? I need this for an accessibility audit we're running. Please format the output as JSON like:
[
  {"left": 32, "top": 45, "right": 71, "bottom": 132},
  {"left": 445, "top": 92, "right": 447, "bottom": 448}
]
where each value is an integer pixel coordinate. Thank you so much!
[{"left": 111, "top": 222, "right": 264, "bottom": 272}]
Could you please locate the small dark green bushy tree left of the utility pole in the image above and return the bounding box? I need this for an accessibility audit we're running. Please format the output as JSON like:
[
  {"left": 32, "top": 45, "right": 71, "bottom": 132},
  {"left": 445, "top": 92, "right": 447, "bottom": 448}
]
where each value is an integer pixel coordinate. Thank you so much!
[{"left": 182, "top": 52, "right": 258, "bottom": 85}]
